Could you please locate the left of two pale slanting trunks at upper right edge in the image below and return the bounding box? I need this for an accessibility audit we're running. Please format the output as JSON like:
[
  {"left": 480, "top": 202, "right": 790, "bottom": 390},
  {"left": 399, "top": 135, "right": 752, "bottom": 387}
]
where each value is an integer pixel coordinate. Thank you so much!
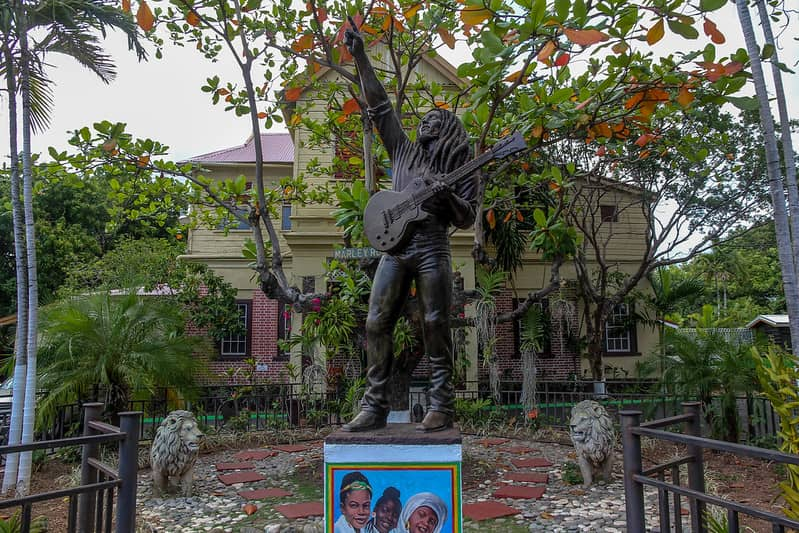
[{"left": 735, "top": 0, "right": 799, "bottom": 358}]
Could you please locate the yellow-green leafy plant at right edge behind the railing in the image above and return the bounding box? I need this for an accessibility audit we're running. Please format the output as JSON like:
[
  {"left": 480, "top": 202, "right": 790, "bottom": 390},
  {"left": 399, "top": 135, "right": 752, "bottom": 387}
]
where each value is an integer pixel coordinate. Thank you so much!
[{"left": 752, "top": 346, "right": 799, "bottom": 520}]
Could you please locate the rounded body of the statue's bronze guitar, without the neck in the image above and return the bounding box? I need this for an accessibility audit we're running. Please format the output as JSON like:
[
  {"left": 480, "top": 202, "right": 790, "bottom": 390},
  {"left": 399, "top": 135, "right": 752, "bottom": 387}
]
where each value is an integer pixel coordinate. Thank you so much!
[{"left": 363, "top": 187, "right": 427, "bottom": 252}]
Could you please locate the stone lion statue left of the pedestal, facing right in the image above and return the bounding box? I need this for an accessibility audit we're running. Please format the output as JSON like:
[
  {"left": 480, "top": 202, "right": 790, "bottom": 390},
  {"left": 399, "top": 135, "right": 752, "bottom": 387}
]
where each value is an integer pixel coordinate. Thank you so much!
[{"left": 150, "top": 410, "right": 205, "bottom": 497}]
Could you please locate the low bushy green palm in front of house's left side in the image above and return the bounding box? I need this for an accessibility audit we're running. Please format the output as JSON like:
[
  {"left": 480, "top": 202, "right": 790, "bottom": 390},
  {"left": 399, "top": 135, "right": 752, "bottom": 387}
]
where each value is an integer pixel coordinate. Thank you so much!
[{"left": 39, "top": 291, "right": 199, "bottom": 419}]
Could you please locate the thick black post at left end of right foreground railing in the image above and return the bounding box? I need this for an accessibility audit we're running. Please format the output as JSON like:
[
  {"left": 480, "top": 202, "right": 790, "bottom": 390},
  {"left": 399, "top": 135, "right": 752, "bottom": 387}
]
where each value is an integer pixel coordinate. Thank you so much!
[{"left": 619, "top": 410, "right": 646, "bottom": 533}]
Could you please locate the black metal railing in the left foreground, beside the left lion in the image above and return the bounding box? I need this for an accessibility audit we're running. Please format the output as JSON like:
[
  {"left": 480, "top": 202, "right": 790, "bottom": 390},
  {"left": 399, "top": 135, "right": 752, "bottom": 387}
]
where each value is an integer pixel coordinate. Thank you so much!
[{"left": 0, "top": 403, "right": 141, "bottom": 533}]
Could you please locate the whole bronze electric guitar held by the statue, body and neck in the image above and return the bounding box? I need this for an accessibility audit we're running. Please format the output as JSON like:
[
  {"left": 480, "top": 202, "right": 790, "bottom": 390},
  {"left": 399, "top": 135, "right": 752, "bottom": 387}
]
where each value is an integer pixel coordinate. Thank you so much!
[{"left": 363, "top": 132, "right": 527, "bottom": 252}]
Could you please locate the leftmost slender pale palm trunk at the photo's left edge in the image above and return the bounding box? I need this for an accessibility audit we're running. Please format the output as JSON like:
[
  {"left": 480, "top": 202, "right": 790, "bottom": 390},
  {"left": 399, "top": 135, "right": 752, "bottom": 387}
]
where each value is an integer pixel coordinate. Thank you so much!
[{"left": 2, "top": 30, "right": 28, "bottom": 494}]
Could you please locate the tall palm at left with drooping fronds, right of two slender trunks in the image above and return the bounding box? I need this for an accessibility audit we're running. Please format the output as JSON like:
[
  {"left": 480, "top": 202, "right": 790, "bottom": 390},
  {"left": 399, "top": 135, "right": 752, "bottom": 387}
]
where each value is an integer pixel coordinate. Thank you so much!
[{"left": 0, "top": 0, "right": 144, "bottom": 495}]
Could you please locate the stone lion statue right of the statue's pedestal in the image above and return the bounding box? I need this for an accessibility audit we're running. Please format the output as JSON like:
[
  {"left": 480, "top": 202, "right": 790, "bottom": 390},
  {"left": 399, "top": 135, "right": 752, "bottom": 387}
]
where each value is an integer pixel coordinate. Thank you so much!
[{"left": 569, "top": 400, "right": 616, "bottom": 487}]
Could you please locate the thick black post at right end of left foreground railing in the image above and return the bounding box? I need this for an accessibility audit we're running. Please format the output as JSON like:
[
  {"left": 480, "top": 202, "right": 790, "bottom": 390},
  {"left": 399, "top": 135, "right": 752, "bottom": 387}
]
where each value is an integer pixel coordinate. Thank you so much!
[{"left": 116, "top": 411, "right": 141, "bottom": 533}]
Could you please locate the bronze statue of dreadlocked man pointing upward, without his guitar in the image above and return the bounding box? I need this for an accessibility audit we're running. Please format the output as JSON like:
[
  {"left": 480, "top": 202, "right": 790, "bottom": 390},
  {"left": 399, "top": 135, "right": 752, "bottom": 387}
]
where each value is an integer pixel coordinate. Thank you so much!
[{"left": 342, "top": 20, "right": 477, "bottom": 432}]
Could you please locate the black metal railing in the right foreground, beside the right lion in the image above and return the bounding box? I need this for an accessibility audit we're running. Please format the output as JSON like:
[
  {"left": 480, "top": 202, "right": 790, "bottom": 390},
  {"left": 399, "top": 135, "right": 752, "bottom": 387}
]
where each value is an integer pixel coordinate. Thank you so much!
[{"left": 620, "top": 402, "right": 799, "bottom": 533}]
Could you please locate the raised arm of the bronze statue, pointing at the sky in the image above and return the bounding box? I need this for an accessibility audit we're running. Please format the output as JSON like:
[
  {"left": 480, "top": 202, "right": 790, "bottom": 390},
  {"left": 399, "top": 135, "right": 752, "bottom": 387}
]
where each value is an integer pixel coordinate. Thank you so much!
[{"left": 344, "top": 17, "right": 407, "bottom": 157}]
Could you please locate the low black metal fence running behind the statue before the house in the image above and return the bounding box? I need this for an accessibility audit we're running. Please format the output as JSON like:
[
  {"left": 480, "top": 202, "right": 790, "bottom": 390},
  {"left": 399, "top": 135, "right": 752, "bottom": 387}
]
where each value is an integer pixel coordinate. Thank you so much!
[{"left": 0, "top": 380, "right": 779, "bottom": 447}]
